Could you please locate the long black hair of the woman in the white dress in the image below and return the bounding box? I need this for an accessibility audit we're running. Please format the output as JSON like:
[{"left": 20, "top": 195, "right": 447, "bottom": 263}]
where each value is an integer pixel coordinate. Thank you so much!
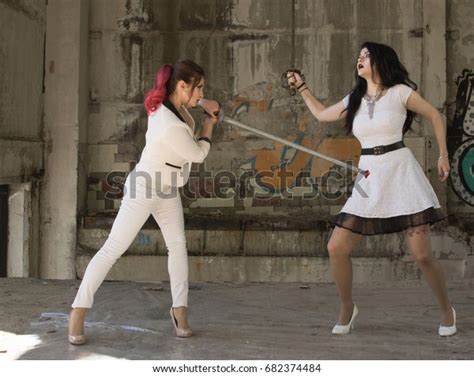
[{"left": 344, "top": 42, "right": 417, "bottom": 134}]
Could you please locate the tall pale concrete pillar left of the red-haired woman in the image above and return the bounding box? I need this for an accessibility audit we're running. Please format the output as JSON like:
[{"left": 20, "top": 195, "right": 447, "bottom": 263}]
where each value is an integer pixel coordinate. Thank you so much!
[{"left": 40, "top": 0, "right": 89, "bottom": 279}]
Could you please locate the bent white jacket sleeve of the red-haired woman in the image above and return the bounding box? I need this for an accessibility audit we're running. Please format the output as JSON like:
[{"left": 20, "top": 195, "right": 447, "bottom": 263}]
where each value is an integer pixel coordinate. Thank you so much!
[{"left": 165, "top": 126, "right": 211, "bottom": 163}]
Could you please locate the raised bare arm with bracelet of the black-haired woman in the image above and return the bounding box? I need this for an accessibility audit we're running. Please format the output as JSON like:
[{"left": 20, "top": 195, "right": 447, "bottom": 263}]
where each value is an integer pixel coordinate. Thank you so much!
[{"left": 288, "top": 72, "right": 347, "bottom": 122}]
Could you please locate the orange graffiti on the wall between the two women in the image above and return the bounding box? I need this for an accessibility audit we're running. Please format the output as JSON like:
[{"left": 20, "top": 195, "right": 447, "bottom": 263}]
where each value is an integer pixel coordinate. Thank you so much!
[{"left": 232, "top": 83, "right": 360, "bottom": 204}]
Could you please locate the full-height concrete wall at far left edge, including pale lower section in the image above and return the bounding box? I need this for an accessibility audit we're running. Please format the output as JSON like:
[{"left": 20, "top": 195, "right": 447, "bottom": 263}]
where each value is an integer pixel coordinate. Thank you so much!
[{"left": 0, "top": 0, "right": 46, "bottom": 277}]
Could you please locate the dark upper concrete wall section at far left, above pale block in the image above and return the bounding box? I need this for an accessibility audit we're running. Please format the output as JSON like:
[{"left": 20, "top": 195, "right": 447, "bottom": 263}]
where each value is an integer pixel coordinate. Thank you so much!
[{"left": 0, "top": 0, "right": 45, "bottom": 184}]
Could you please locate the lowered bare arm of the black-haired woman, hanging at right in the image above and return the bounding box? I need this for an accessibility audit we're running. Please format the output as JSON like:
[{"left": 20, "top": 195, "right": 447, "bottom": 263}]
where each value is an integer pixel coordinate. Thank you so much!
[{"left": 406, "top": 91, "right": 450, "bottom": 181}]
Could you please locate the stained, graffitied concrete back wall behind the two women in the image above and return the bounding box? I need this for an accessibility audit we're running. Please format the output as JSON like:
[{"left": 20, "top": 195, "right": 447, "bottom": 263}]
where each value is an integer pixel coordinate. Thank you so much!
[{"left": 87, "top": 0, "right": 430, "bottom": 217}]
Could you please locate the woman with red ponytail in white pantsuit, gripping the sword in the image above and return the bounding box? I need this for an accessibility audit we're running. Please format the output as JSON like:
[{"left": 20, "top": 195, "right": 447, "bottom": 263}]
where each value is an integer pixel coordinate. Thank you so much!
[{"left": 68, "top": 60, "right": 219, "bottom": 345}]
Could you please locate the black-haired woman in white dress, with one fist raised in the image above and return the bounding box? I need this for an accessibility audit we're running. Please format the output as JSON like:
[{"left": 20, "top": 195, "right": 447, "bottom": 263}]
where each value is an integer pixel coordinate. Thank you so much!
[{"left": 287, "top": 42, "right": 456, "bottom": 336}]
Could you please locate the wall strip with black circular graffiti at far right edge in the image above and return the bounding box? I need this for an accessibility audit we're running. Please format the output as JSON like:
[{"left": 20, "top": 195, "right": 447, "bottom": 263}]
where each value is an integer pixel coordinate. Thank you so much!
[{"left": 446, "top": 0, "right": 474, "bottom": 228}]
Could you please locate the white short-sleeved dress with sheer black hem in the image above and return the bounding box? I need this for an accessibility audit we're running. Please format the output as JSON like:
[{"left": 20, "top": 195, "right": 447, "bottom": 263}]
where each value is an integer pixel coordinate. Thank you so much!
[{"left": 334, "top": 85, "right": 444, "bottom": 235}]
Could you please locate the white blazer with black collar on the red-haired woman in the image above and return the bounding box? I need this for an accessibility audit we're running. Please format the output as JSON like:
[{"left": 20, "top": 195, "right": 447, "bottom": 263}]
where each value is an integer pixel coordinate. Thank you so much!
[{"left": 131, "top": 102, "right": 211, "bottom": 189}]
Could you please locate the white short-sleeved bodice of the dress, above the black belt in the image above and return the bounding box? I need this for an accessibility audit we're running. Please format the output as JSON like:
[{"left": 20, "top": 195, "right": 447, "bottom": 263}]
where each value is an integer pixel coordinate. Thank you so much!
[{"left": 342, "top": 84, "right": 413, "bottom": 148}]
